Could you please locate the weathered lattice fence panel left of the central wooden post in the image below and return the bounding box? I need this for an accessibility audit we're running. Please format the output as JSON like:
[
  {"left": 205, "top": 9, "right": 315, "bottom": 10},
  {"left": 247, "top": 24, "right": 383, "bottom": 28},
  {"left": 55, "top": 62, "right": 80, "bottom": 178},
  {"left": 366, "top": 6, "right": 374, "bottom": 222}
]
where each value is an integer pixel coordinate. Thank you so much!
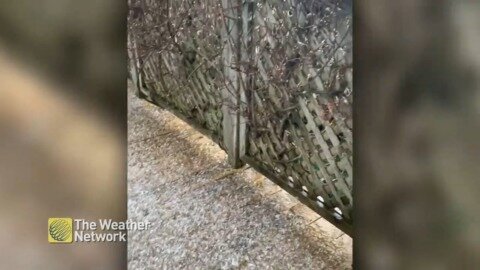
[{"left": 129, "top": 0, "right": 225, "bottom": 145}]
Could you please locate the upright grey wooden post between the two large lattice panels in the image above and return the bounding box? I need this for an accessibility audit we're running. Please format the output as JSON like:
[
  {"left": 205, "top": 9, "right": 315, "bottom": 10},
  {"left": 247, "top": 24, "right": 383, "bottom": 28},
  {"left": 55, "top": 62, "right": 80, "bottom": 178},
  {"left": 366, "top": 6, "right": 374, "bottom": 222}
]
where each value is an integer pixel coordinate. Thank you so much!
[{"left": 222, "top": 0, "right": 253, "bottom": 168}]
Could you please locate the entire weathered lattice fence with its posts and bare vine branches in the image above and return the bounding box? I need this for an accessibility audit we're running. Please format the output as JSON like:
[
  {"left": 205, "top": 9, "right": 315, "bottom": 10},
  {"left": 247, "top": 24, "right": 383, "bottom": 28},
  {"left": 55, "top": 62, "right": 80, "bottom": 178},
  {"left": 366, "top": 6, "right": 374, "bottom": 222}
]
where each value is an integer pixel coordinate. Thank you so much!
[{"left": 129, "top": 0, "right": 353, "bottom": 234}]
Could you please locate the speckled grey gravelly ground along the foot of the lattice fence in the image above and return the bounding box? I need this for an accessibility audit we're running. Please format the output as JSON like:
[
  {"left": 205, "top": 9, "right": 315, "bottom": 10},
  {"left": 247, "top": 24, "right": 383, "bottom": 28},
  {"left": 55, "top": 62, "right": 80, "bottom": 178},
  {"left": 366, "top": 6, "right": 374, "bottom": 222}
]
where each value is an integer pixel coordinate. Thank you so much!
[{"left": 128, "top": 87, "right": 352, "bottom": 269}]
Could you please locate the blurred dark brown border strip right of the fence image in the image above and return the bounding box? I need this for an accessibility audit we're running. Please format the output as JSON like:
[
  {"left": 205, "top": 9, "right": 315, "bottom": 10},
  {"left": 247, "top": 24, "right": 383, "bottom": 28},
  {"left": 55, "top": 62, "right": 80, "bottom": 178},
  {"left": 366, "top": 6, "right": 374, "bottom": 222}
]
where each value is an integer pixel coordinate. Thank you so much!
[{"left": 353, "top": 0, "right": 480, "bottom": 269}]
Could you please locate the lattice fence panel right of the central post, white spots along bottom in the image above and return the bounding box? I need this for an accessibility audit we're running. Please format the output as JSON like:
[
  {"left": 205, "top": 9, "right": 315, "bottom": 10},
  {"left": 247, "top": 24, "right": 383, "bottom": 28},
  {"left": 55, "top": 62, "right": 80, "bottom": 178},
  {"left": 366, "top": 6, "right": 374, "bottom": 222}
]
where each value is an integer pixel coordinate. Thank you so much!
[{"left": 246, "top": 0, "right": 353, "bottom": 224}]
